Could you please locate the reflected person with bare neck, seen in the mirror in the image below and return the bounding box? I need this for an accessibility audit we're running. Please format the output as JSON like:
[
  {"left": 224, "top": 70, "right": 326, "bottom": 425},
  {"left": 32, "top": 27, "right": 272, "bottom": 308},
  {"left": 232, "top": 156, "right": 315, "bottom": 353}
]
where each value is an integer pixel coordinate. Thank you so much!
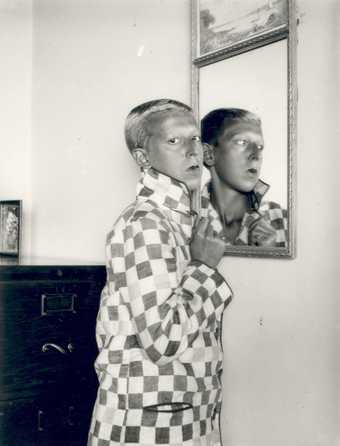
[{"left": 201, "top": 108, "right": 287, "bottom": 247}]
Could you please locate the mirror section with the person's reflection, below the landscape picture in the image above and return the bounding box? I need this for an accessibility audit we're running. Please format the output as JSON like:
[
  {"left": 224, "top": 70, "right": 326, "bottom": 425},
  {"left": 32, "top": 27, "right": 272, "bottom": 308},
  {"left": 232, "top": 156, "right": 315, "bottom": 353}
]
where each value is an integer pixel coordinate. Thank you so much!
[{"left": 192, "top": 13, "right": 296, "bottom": 257}]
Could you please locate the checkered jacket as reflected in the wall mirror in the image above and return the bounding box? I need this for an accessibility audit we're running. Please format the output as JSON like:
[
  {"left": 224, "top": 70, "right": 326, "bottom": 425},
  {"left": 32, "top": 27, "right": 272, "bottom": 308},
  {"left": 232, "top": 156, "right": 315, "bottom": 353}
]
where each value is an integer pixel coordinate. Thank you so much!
[{"left": 202, "top": 180, "right": 288, "bottom": 247}]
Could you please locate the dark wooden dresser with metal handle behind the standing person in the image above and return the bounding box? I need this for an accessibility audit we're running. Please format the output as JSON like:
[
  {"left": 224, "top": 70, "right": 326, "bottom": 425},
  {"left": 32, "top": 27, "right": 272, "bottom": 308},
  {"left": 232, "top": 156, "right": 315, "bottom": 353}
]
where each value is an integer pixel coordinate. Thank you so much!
[{"left": 0, "top": 261, "right": 105, "bottom": 446}]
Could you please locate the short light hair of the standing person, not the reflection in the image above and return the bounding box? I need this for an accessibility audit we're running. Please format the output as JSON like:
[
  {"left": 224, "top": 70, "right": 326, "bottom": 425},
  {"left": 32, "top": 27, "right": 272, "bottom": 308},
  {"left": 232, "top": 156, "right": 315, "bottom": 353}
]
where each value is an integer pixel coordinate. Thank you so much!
[{"left": 125, "top": 99, "right": 194, "bottom": 153}]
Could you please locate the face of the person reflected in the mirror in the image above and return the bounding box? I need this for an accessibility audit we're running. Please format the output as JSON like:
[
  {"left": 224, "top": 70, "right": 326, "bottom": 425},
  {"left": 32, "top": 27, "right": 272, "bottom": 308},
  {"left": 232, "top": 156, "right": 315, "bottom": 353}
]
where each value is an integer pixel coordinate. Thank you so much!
[{"left": 214, "top": 123, "right": 264, "bottom": 193}]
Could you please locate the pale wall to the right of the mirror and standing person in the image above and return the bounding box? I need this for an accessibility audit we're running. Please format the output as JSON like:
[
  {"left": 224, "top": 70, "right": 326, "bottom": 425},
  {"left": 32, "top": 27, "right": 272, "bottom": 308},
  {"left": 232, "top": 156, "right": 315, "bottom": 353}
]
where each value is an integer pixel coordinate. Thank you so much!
[{"left": 222, "top": 0, "right": 340, "bottom": 446}]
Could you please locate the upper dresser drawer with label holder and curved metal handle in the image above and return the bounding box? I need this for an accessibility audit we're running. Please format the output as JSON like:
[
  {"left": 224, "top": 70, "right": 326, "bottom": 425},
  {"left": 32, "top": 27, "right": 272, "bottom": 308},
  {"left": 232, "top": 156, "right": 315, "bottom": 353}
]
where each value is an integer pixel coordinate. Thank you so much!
[{"left": 0, "top": 282, "right": 99, "bottom": 394}]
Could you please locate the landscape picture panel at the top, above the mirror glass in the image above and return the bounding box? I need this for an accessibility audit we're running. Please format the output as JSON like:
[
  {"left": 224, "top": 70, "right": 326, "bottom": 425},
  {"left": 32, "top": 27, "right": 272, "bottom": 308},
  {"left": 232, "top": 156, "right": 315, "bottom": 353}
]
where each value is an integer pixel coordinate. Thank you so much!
[{"left": 192, "top": 0, "right": 289, "bottom": 60}]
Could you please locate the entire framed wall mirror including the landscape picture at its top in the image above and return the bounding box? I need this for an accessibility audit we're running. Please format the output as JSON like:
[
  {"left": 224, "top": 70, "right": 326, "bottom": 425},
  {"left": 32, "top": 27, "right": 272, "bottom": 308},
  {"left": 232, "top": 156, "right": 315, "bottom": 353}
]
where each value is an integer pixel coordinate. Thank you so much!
[{"left": 192, "top": 0, "right": 296, "bottom": 258}]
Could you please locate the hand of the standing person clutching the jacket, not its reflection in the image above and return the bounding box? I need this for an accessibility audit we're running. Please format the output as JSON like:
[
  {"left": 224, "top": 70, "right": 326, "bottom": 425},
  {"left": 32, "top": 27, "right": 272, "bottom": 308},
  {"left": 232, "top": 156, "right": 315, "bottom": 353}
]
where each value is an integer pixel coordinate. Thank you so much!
[{"left": 190, "top": 218, "right": 225, "bottom": 268}]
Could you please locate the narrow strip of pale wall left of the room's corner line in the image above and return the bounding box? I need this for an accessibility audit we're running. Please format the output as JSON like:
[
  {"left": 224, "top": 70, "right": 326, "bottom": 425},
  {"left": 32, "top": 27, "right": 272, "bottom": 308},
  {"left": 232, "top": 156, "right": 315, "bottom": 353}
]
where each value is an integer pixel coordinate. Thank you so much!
[{"left": 0, "top": 0, "right": 32, "bottom": 253}]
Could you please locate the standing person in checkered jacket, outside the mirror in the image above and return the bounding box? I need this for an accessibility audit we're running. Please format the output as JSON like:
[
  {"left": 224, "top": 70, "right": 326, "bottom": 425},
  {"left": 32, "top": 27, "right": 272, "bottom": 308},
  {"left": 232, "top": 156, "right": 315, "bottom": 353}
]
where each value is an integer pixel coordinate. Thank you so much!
[{"left": 88, "top": 99, "right": 232, "bottom": 446}]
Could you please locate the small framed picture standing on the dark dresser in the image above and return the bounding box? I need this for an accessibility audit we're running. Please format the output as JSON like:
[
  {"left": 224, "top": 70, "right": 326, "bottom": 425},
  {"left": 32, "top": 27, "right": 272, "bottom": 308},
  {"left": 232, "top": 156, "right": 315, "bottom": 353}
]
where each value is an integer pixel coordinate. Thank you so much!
[{"left": 0, "top": 200, "right": 22, "bottom": 257}]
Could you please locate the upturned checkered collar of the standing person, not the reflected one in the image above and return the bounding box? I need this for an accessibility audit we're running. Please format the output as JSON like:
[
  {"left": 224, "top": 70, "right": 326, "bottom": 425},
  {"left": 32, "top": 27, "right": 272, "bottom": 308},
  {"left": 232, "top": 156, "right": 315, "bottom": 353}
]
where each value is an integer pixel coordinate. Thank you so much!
[{"left": 137, "top": 168, "right": 192, "bottom": 215}]
